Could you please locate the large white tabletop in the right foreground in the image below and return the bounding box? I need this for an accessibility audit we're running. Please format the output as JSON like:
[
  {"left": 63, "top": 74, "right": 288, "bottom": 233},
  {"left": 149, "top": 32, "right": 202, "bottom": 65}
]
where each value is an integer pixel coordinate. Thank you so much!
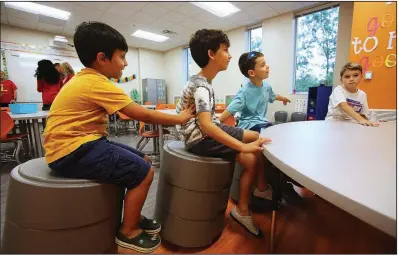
[{"left": 261, "top": 121, "right": 396, "bottom": 236}]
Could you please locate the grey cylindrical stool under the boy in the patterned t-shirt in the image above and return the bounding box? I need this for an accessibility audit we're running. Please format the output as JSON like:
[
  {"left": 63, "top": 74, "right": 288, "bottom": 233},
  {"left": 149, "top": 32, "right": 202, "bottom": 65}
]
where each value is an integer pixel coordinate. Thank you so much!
[{"left": 155, "top": 141, "right": 234, "bottom": 247}]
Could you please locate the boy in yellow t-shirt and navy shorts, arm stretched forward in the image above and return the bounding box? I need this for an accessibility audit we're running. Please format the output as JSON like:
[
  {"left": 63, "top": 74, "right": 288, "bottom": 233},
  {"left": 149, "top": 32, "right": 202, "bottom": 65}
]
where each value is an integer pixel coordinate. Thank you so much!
[{"left": 43, "top": 22, "right": 194, "bottom": 253}]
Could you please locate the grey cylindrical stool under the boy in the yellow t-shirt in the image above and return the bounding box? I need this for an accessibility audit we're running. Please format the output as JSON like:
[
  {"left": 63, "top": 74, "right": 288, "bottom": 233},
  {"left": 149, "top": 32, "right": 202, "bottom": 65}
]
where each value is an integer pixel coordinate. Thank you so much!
[{"left": 2, "top": 158, "right": 123, "bottom": 254}]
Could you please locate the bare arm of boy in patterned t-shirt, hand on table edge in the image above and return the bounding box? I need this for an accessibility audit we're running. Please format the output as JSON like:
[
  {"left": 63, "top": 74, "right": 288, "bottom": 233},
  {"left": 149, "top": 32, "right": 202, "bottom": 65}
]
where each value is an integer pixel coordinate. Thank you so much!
[{"left": 198, "top": 112, "right": 271, "bottom": 153}]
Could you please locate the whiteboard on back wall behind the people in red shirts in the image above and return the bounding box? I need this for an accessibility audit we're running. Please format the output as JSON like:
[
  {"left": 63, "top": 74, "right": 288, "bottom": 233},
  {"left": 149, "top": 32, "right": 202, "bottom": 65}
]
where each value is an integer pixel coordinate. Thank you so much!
[{"left": 1, "top": 50, "right": 84, "bottom": 103}]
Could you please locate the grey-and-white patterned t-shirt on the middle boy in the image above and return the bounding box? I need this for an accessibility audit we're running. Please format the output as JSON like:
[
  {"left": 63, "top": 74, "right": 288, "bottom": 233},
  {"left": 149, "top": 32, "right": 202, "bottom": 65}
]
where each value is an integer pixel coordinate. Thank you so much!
[{"left": 176, "top": 75, "right": 220, "bottom": 149}]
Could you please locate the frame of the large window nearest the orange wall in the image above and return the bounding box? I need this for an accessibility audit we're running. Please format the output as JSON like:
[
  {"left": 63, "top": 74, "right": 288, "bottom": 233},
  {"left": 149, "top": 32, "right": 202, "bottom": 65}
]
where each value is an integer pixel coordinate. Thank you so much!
[{"left": 289, "top": 2, "right": 340, "bottom": 95}]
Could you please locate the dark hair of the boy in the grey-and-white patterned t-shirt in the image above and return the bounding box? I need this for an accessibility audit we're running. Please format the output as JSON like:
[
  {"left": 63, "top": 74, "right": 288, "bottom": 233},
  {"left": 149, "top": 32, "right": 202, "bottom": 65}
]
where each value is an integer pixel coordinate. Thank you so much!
[{"left": 189, "top": 29, "right": 230, "bottom": 68}]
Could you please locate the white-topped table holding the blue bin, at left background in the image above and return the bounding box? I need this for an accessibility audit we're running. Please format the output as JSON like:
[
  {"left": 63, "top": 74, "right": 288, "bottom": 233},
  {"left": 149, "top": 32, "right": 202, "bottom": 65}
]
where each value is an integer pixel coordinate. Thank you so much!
[{"left": 10, "top": 111, "right": 48, "bottom": 158}]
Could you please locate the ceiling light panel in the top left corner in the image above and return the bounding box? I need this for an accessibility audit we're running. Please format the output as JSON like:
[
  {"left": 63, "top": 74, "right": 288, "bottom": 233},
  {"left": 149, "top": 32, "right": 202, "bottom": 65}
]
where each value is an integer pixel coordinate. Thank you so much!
[{"left": 5, "top": 2, "right": 71, "bottom": 20}]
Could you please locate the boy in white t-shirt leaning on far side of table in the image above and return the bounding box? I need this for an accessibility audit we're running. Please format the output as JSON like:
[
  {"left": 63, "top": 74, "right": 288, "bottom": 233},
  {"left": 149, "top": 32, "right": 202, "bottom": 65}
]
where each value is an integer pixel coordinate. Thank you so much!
[{"left": 326, "top": 62, "right": 378, "bottom": 127}]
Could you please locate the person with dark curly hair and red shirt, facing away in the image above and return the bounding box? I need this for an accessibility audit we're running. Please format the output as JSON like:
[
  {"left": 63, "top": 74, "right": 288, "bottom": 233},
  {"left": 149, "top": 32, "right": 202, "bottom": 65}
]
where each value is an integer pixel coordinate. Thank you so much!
[{"left": 35, "top": 59, "right": 64, "bottom": 111}]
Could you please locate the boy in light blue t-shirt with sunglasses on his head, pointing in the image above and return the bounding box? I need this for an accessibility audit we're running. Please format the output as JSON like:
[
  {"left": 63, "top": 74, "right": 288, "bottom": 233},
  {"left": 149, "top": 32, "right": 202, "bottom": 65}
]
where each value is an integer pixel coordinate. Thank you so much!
[{"left": 219, "top": 51, "right": 299, "bottom": 202}]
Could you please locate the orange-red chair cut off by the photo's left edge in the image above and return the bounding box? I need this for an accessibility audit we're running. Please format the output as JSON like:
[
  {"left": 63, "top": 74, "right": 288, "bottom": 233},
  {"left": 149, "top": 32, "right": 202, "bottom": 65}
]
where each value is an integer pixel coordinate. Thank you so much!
[{"left": 0, "top": 111, "right": 28, "bottom": 165}]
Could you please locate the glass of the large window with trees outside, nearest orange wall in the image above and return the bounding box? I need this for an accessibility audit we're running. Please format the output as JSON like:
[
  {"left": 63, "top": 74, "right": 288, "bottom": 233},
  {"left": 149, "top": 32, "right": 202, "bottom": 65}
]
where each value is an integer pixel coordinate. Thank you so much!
[{"left": 293, "top": 6, "right": 339, "bottom": 94}]
